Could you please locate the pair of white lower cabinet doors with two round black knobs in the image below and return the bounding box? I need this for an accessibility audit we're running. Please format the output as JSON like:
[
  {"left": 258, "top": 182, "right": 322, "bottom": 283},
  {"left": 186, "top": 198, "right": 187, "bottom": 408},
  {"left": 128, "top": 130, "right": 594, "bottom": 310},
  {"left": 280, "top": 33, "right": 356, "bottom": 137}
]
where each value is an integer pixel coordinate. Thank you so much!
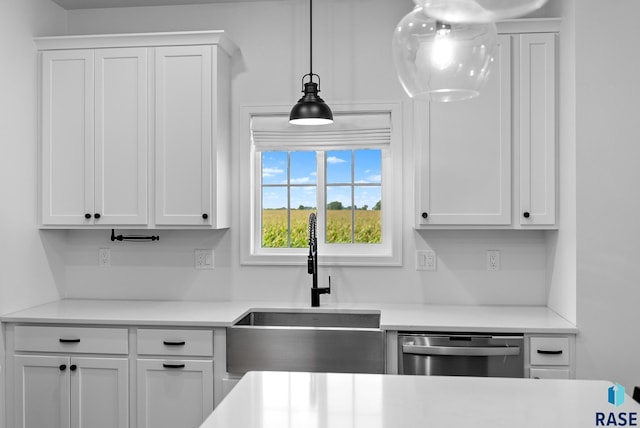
[{"left": 13, "top": 355, "right": 129, "bottom": 428}]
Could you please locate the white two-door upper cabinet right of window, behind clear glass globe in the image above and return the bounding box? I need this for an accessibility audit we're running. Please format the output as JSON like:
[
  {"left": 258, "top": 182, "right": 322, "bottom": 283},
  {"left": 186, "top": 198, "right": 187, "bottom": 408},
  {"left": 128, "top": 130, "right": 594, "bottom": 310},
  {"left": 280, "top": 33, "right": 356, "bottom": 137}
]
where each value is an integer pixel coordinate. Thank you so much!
[{"left": 414, "top": 24, "right": 557, "bottom": 229}]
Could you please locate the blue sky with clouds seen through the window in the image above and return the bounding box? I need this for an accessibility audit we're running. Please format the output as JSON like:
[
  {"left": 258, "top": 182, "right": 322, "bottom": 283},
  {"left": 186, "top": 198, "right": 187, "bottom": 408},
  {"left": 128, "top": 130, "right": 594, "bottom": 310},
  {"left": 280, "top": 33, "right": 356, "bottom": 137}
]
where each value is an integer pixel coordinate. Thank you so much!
[{"left": 262, "top": 150, "right": 382, "bottom": 209}]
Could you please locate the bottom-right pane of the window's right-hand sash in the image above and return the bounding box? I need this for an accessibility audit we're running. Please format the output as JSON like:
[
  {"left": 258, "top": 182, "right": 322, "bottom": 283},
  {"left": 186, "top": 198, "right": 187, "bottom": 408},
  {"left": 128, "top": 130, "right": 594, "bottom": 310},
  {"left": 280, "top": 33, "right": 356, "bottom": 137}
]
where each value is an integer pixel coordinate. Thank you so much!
[{"left": 354, "top": 186, "right": 382, "bottom": 244}]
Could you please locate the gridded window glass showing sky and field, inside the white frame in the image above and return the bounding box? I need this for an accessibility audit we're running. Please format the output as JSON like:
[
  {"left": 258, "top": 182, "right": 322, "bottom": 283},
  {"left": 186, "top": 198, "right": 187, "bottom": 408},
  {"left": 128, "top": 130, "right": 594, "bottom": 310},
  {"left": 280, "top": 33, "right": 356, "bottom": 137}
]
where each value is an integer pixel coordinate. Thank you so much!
[{"left": 260, "top": 149, "right": 382, "bottom": 248}]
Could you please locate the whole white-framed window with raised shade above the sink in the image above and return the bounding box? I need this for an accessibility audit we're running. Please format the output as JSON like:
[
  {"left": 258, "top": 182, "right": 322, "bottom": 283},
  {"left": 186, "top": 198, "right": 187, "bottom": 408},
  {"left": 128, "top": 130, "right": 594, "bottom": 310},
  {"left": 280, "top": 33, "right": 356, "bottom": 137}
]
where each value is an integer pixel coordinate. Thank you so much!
[{"left": 241, "top": 105, "right": 402, "bottom": 265}]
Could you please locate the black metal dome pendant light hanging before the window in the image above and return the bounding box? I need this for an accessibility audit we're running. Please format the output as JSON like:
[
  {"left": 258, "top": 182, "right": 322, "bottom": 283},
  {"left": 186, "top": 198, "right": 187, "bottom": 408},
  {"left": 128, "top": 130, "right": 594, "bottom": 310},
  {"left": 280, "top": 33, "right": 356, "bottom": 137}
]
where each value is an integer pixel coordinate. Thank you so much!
[{"left": 289, "top": 0, "right": 333, "bottom": 125}]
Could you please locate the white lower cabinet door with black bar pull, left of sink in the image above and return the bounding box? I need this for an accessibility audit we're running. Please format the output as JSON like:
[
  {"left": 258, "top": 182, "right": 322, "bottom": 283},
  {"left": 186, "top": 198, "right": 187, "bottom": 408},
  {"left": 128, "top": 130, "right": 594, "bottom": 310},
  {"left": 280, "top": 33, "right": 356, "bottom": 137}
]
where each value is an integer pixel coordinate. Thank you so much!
[{"left": 137, "top": 359, "right": 213, "bottom": 428}]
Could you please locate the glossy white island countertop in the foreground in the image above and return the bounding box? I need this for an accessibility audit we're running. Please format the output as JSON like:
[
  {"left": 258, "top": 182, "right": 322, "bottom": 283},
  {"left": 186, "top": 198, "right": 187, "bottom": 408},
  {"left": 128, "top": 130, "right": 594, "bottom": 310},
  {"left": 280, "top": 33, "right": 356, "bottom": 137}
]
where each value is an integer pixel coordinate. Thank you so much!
[{"left": 200, "top": 372, "right": 640, "bottom": 428}]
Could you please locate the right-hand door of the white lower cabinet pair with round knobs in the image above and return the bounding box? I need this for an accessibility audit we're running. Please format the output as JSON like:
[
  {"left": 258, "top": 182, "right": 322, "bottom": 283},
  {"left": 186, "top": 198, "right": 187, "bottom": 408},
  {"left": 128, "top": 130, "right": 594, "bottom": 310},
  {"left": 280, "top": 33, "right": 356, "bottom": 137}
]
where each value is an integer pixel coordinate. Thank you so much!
[{"left": 69, "top": 357, "right": 129, "bottom": 428}]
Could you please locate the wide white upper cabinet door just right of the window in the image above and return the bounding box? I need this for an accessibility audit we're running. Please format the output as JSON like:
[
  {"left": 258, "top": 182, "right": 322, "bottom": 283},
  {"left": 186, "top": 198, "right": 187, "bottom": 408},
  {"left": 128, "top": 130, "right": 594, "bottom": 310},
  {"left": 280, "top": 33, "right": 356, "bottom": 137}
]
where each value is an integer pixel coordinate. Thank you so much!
[{"left": 414, "top": 35, "right": 512, "bottom": 226}]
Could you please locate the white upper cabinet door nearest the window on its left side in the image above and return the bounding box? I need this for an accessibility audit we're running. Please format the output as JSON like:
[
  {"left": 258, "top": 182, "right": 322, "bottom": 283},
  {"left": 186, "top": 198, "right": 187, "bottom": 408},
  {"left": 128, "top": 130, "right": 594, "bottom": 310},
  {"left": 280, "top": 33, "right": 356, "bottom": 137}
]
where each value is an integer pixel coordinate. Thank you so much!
[{"left": 155, "top": 46, "right": 213, "bottom": 226}]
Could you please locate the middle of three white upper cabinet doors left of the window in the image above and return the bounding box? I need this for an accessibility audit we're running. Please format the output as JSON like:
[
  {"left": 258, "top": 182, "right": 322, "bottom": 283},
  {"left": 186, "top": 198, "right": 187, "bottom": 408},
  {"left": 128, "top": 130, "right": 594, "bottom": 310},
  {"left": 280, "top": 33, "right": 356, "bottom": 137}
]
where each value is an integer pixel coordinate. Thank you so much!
[{"left": 95, "top": 48, "right": 149, "bottom": 225}]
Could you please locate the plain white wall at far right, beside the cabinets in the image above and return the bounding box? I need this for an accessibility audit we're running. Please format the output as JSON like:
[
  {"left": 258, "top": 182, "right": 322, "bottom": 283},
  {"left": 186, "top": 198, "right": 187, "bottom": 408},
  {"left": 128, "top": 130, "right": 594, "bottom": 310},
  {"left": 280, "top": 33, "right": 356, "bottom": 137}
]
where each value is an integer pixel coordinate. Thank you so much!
[{"left": 575, "top": 0, "right": 640, "bottom": 391}]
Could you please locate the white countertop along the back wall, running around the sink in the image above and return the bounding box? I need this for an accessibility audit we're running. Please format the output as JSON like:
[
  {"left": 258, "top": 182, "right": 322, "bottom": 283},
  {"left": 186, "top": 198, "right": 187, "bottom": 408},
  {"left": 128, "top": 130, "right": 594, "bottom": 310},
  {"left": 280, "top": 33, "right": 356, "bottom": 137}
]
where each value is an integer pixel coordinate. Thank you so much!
[{"left": 0, "top": 299, "right": 577, "bottom": 333}]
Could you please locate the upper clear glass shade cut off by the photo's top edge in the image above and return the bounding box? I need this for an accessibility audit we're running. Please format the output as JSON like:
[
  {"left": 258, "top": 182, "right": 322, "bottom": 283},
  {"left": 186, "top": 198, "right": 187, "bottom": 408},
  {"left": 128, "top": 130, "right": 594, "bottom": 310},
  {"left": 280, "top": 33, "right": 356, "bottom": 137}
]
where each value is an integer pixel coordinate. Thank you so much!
[{"left": 413, "top": 0, "right": 547, "bottom": 23}]
